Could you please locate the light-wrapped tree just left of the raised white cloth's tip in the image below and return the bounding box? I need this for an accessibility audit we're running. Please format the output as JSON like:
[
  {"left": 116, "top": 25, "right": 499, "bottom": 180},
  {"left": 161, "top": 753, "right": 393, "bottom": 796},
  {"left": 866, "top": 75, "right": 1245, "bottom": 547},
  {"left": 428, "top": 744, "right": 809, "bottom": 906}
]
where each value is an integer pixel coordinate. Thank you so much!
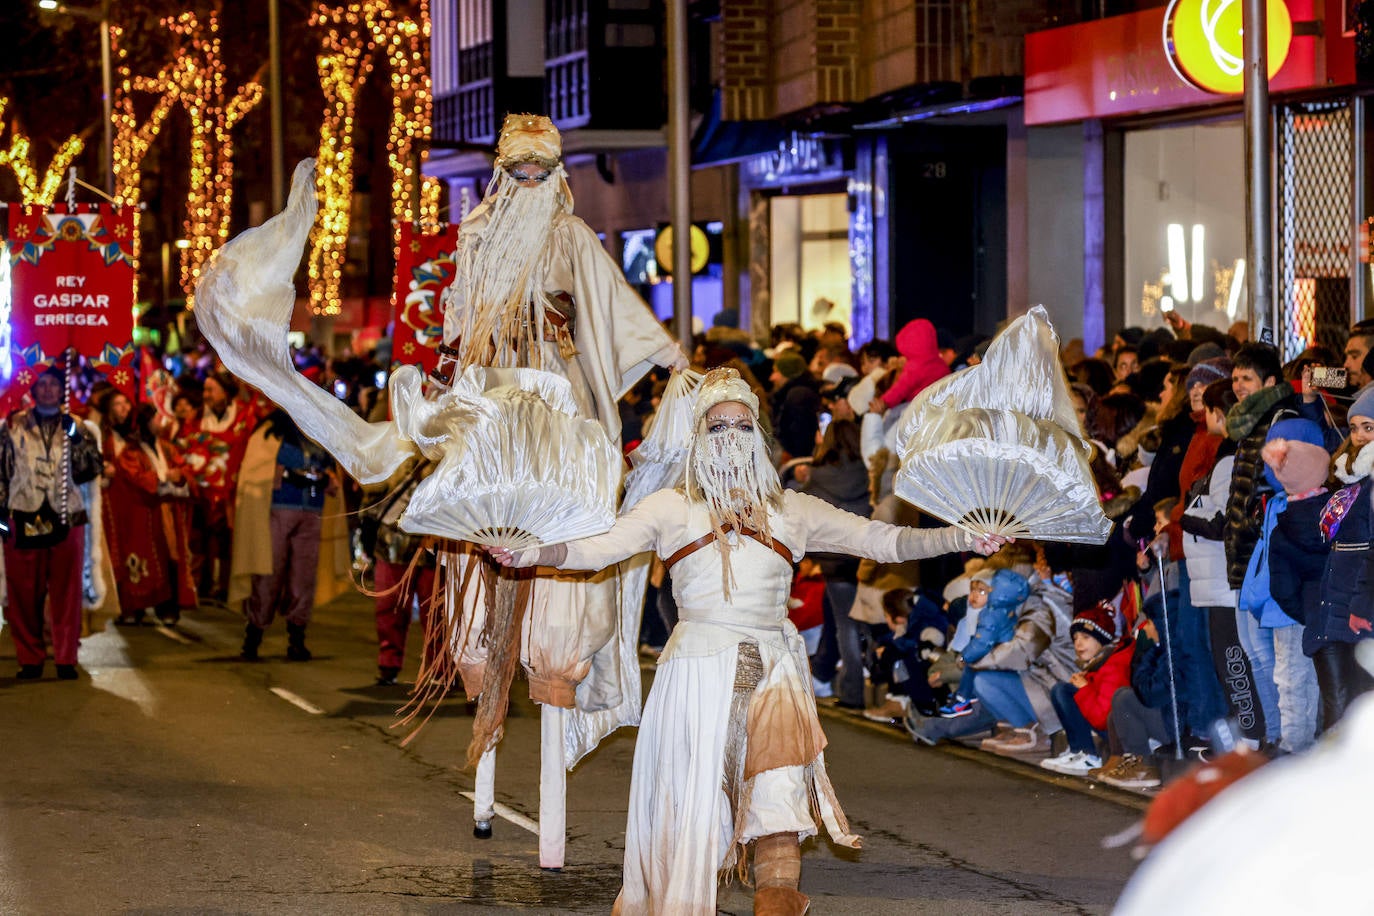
[{"left": 131, "top": 12, "right": 262, "bottom": 308}]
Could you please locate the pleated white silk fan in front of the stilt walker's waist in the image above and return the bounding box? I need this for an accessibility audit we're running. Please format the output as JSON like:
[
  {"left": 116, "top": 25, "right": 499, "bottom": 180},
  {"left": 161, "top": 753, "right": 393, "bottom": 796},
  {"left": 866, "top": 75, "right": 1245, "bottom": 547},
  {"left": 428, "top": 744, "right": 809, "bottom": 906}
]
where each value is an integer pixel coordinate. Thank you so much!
[{"left": 401, "top": 367, "right": 624, "bottom": 548}]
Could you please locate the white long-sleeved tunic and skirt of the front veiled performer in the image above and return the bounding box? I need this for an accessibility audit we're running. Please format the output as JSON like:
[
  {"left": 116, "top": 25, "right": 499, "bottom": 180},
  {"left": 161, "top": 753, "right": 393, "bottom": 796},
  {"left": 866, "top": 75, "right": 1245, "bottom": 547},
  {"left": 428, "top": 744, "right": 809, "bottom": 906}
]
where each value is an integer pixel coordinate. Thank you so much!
[{"left": 562, "top": 490, "right": 970, "bottom": 913}]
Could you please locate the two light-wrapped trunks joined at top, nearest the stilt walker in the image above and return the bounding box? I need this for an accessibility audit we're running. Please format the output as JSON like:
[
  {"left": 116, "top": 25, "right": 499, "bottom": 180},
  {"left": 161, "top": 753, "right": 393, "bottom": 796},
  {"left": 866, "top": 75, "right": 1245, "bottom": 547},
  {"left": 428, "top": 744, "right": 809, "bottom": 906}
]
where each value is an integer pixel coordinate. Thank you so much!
[{"left": 309, "top": 0, "right": 441, "bottom": 314}]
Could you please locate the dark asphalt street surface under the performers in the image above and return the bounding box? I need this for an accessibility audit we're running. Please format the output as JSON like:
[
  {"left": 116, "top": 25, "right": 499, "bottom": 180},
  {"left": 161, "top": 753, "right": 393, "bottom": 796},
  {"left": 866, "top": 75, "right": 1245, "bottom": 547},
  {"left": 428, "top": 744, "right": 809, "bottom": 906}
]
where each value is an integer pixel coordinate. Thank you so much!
[{"left": 0, "top": 595, "right": 1143, "bottom": 916}]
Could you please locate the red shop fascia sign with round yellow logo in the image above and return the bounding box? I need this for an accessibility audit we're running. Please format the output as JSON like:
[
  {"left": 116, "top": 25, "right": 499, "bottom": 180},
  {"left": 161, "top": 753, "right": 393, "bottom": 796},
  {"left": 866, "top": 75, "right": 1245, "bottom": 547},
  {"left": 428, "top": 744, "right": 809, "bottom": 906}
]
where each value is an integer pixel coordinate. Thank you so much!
[{"left": 1025, "top": 0, "right": 1355, "bottom": 125}]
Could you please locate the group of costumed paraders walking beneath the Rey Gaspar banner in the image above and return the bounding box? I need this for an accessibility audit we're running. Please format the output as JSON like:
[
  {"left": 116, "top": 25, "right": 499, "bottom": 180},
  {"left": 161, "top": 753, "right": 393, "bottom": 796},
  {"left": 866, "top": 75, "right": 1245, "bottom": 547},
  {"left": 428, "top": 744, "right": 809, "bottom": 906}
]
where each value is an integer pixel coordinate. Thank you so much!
[{"left": 0, "top": 345, "right": 409, "bottom": 683}]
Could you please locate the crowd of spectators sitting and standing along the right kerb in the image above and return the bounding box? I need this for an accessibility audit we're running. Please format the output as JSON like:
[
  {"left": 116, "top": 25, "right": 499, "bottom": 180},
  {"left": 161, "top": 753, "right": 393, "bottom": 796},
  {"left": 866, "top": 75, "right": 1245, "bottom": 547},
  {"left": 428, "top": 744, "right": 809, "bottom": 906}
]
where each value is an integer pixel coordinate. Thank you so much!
[{"left": 628, "top": 307, "right": 1374, "bottom": 788}]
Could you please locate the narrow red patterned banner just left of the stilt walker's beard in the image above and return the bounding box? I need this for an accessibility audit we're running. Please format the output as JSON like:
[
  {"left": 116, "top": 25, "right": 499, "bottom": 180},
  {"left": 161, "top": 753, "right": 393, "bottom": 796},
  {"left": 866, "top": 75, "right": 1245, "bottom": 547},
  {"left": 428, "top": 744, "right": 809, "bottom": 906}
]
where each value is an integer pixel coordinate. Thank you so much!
[{"left": 392, "top": 222, "right": 458, "bottom": 372}]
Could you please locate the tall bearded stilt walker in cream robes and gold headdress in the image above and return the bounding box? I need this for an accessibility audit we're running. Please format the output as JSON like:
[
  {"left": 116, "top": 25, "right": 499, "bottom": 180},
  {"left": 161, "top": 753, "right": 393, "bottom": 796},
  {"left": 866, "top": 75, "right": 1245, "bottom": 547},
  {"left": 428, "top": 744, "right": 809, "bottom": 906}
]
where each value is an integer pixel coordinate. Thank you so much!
[{"left": 436, "top": 114, "right": 686, "bottom": 868}]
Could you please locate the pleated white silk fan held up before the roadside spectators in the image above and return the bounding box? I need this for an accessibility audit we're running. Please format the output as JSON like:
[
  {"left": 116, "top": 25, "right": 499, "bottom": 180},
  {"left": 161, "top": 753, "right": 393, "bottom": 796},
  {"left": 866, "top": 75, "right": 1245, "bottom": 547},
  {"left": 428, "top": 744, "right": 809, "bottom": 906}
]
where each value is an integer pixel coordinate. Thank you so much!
[{"left": 893, "top": 305, "right": 1112, "bottom": 544}]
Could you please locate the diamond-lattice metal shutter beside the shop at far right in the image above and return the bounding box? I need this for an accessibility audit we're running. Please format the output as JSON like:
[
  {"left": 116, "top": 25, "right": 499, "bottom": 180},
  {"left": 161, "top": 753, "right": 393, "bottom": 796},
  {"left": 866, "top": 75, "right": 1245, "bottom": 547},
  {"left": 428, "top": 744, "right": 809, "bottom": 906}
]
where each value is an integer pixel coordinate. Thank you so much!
[{"left": 1276, "top": 99, "right": 1355, "bottom": 360}]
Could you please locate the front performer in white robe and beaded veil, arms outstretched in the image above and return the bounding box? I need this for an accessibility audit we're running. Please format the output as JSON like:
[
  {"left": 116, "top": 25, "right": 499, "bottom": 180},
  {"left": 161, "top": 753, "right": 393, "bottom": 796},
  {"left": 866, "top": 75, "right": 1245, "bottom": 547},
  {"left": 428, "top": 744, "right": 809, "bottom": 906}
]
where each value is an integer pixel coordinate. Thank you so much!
[{"left": 491, "top": 369, "right": 1004, "bottom": 915}]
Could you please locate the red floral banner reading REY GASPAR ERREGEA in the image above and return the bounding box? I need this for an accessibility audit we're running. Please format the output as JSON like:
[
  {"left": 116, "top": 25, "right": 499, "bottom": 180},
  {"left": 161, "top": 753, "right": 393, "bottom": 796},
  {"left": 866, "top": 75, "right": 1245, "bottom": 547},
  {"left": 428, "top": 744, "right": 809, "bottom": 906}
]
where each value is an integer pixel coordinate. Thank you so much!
[{"left": 0, "top": 203, "right": 136, "bottom": 409}]
